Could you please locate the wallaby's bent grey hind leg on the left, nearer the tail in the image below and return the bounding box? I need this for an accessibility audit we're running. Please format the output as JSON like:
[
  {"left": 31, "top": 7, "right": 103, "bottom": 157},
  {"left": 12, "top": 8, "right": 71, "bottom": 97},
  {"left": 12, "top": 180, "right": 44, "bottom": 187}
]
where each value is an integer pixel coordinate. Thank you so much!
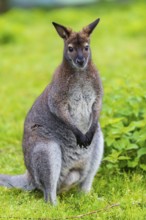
[{"left": 32, "top": 141, "right": 61, "bottom": 205}]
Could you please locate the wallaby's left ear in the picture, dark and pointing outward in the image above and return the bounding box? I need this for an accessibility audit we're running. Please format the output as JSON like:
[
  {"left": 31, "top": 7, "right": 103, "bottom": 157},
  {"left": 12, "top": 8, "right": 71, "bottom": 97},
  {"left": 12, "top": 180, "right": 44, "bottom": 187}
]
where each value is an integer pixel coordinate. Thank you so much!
[{"left": 52, "top": 22, "right": 71, "bottom": 39}]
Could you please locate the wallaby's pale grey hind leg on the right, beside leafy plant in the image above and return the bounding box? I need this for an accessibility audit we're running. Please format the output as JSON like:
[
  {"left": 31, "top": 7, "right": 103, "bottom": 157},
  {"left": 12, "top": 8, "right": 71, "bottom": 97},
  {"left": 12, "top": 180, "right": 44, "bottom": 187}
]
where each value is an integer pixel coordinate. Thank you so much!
[{"left": 80, "top": 125, "right": 104, "bottom": 192}]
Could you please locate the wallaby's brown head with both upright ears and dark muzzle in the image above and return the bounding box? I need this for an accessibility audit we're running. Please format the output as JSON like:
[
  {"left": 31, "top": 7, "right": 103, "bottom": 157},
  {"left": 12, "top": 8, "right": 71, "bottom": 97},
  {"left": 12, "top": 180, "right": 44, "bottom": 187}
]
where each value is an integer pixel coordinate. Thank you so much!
[{"left": 53, "top": 18, "right": 100, "bottom": 70}]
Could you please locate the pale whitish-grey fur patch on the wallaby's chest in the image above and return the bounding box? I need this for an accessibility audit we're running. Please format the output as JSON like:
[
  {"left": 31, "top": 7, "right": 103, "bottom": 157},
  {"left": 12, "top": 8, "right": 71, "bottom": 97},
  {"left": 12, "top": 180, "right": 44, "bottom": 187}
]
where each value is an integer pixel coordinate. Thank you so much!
[{"left": 68, "top": 79, "right": 96, "bottom": 133}]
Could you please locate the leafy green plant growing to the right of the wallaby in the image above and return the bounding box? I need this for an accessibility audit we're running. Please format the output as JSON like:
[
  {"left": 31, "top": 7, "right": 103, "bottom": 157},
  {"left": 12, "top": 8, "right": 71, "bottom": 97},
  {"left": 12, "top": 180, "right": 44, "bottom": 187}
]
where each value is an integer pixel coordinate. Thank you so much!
[{"left": 102, "top": 84, "right": 146, "bottom": 171}]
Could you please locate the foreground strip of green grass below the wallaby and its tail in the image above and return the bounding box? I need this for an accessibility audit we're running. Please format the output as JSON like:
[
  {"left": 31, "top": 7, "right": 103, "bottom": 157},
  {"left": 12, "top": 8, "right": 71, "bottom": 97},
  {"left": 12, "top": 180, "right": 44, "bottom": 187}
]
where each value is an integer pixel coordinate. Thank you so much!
[{"left": 0, "top": 173, "right": 146, "bottom": 220}]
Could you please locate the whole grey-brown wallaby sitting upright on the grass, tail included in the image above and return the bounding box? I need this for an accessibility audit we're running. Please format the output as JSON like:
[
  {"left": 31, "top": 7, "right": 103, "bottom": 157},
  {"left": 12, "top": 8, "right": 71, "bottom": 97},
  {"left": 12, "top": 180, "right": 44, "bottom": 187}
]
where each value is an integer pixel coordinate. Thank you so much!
[{"left": 0, "top": 19, "right": 104, "bottom": 205}]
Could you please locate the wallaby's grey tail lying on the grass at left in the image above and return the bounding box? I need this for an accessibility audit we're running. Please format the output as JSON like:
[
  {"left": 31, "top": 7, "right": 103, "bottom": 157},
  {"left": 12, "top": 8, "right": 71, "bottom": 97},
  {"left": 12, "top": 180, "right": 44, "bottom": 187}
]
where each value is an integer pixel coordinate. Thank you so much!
[{"left": 0, "top": 172, "right": 36, "bottom": 190}]
